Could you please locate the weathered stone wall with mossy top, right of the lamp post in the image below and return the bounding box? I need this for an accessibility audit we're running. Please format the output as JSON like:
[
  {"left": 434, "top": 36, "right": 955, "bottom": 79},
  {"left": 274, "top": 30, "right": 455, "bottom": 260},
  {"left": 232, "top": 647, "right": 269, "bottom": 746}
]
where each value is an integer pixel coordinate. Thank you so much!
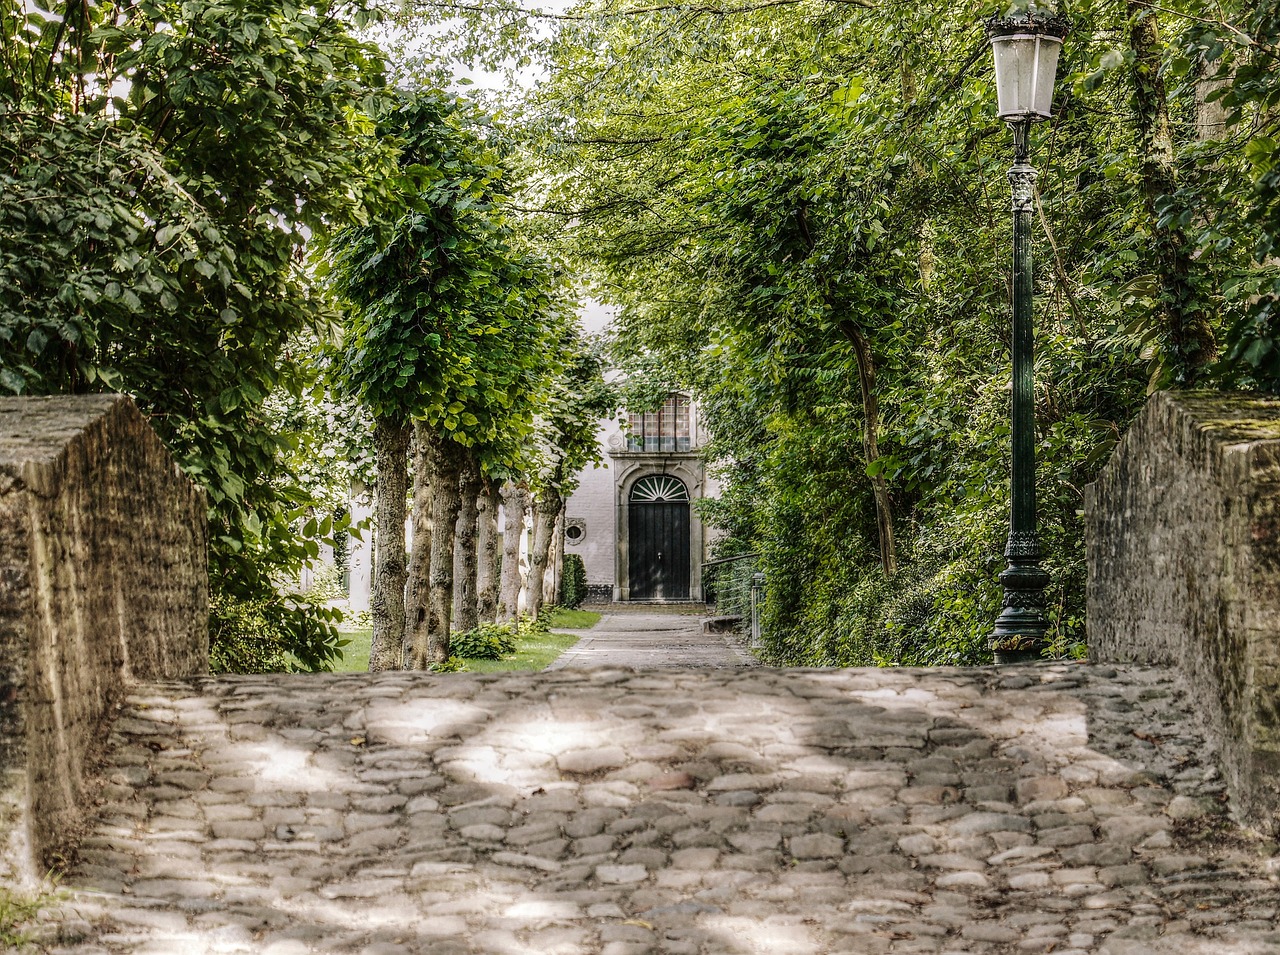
[{"left": 1085, "top": 392, "right": 1280, "bottom": 824}]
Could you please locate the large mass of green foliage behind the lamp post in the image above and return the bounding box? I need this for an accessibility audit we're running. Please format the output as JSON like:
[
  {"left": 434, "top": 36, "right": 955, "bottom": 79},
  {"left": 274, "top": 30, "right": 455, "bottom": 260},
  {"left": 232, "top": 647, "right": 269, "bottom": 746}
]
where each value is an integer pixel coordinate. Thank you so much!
[{"left": 517, "top": 0, "right": 1280, "bottom": 664}]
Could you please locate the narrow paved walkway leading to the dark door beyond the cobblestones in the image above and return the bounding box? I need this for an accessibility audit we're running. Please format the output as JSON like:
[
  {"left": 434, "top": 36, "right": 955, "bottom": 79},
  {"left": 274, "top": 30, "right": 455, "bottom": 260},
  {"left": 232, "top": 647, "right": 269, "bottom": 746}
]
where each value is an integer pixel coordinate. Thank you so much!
[{"left": 548, "top": 609, "right": 755, "bottom": 670}]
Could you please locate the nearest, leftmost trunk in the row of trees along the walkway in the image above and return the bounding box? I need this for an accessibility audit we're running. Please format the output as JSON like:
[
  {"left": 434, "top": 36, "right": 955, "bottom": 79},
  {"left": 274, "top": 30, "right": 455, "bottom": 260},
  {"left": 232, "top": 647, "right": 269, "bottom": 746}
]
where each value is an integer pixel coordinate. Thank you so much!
[{"left": 369, "top": 417, "right": 410, "bottom": 673}]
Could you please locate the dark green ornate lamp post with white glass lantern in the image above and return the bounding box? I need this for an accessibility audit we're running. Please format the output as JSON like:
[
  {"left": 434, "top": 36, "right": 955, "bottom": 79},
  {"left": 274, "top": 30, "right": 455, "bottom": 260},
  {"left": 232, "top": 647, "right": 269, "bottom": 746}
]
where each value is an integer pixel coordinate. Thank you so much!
[{"left": 987, "top": 13, "right": 1068, "bottom": 663}]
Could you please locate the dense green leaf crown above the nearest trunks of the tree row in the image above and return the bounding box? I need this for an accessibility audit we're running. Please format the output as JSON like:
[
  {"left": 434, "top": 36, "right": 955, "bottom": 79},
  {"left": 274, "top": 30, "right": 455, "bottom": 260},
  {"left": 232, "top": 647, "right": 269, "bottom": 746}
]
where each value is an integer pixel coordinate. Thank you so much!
[{"left": 323, "top": 91, "right": 568, "bottom": 462}]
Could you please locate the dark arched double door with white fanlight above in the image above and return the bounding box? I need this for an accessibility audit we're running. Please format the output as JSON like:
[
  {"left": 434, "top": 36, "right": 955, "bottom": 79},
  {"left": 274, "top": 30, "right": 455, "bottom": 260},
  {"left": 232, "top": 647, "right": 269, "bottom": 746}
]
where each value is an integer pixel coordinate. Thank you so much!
[{"left": 627, "top": 474, "right": 689, "bottom": 600}]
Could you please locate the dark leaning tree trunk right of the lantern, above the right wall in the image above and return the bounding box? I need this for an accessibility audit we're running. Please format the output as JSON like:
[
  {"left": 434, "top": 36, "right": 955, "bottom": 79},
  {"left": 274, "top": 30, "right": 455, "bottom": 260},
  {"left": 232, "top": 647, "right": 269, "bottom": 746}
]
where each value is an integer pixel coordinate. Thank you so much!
[{"left": 1128, "top": 0, "right": 1217, "bottom": 387}]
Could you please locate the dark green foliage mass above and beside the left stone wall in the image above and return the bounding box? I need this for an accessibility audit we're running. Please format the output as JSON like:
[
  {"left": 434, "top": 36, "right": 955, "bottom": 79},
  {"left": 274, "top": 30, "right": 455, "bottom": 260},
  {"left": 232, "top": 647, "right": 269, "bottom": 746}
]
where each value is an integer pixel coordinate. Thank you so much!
[{"left": 0, "top": 0, "right": 385, "bottom": 664}]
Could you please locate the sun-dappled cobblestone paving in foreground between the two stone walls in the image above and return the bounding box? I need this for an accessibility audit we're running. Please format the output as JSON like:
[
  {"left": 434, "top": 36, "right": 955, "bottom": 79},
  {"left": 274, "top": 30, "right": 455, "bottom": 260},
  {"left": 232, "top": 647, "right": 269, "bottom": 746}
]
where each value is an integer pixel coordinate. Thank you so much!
[{"left": 51, "top": 664, "right": 1280, "bottom": 955}]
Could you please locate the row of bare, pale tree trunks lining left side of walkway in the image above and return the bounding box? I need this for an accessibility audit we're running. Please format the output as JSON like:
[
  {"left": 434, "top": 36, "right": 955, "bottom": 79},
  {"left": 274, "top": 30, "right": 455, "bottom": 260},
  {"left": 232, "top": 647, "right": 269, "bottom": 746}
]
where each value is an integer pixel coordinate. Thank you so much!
[{"left": 369, "top": 419, "right": 564, "bottom": 672}]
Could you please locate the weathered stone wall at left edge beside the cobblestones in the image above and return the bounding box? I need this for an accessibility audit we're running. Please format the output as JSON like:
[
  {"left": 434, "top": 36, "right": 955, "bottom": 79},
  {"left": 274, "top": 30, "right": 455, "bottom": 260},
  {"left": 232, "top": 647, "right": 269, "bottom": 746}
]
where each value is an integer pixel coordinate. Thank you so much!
[{"left": 0, "top": 394, "right": 209, "bottom": 882}]
